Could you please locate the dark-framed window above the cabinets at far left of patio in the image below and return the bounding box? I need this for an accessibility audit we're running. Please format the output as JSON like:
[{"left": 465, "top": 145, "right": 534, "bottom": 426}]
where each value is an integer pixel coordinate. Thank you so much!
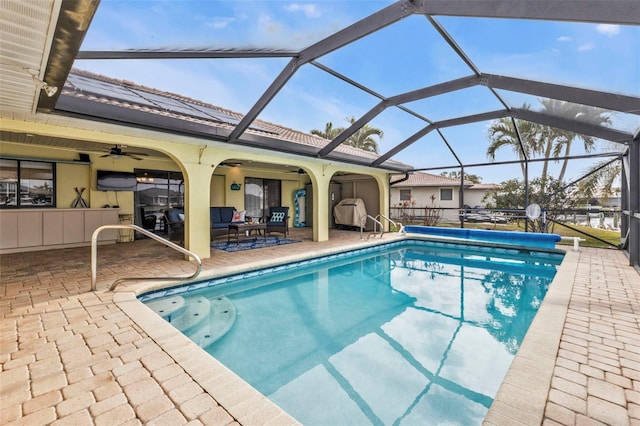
[{"left": 0, "top": 159, "right": 55, "bottom": 209}]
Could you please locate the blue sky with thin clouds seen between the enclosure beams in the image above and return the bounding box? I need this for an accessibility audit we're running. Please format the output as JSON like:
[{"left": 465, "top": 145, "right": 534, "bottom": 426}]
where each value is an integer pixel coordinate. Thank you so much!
[{"left": 75, "top": 0, "right": 640, "bottom": 182}]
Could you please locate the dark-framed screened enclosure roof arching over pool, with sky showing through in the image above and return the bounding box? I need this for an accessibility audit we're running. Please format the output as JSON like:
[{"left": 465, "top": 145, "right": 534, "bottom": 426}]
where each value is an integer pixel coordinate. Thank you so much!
[{"left": 1, "top": 0, "right": 640, "bottom": 181}]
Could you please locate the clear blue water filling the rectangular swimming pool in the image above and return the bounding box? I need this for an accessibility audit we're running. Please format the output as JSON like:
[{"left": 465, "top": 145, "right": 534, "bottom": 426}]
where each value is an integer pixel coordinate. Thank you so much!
[{"left": 141, "top": 241, "right": 562, "bottom": 425}]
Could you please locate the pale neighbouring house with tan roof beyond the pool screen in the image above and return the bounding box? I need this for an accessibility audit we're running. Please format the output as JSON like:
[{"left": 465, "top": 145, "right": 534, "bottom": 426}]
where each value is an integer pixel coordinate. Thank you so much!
[{"left": 389, "top": 172, "right": 498, "bottom": 221}]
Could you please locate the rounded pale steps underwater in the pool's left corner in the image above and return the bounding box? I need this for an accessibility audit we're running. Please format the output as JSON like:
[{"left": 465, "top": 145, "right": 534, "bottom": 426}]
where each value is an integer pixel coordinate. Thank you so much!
[{"left": 147, "top": 295, "right": 236, "bottom": 348}]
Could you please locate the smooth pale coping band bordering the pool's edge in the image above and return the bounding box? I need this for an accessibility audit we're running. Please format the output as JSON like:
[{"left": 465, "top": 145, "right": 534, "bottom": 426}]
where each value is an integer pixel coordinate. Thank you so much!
[{"left": 113, "top": 234, "right": 568, "bottom": 425}]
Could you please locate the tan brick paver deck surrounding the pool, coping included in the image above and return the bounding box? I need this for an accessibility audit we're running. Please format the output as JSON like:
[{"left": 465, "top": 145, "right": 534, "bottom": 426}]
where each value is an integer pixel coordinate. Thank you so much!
[{"left": 0, "top": 230, "right": 640, "bottom": 425}]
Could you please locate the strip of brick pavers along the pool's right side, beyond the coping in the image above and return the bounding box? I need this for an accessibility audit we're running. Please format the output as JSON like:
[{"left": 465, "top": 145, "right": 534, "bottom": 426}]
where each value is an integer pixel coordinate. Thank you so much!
[{"left": 544, "top": 249, "right": 640, "bottom": 426}]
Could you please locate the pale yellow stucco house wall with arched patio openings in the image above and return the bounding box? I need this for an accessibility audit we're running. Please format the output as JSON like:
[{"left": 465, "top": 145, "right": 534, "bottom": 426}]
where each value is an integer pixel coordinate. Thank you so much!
[{"left": 0, "top": 117, "right": 389, "bottom": 258}]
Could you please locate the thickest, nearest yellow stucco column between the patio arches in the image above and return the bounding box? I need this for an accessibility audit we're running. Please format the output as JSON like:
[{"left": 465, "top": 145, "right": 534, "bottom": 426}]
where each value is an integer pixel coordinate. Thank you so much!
[{"left": 183, "top": 163, "right": 211, "bottom": 259}]
